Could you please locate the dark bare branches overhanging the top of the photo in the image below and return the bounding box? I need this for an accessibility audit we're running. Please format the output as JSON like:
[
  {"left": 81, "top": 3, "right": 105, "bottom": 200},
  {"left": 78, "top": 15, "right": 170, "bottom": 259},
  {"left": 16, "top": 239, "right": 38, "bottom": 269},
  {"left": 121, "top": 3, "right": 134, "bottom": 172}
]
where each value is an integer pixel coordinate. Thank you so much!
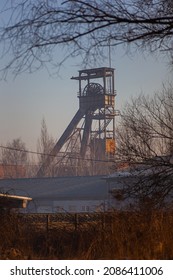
[{"left": 0, "top": 0, "right": 173, "bottom": 74}]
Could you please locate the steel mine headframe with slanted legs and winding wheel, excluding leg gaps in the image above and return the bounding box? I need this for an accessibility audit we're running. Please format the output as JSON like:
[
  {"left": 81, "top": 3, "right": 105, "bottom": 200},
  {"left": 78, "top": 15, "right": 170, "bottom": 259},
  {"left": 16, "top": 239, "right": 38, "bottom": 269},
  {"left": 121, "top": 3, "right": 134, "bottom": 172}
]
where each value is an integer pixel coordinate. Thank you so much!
[{"left": 37, "top": 67, "right": 116, "bottom": 177}]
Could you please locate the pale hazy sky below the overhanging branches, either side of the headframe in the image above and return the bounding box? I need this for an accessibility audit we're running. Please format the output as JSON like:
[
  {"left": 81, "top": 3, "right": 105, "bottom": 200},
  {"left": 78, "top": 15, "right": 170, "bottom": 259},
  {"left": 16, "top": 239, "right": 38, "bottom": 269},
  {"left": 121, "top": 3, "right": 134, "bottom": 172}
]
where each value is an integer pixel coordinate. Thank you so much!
[{"left": 0, "top": 2, "right": 173, "bottom": 150}]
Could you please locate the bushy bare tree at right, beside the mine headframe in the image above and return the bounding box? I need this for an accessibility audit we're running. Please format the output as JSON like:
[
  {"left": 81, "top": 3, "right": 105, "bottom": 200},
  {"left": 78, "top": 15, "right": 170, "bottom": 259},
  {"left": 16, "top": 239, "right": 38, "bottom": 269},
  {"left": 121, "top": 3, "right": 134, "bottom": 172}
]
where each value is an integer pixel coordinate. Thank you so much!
[{"left": 116, "top": 85, "right": 173, "bottom": 208}]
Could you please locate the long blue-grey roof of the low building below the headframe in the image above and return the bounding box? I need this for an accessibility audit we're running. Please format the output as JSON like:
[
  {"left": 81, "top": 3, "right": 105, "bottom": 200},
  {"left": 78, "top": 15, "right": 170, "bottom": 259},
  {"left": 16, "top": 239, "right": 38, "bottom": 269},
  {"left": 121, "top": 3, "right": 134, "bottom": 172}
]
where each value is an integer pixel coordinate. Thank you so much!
[{"left": 0, "top": 176, "right": 108, "bottom": 200}]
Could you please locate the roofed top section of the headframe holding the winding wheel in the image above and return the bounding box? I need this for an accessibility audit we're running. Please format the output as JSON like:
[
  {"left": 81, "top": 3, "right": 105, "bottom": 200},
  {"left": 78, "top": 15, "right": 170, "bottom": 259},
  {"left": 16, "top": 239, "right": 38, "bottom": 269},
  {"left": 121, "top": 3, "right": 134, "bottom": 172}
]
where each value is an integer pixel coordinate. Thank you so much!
[{"left": 71, "top": 67, "right": 115, "bottom": 112}]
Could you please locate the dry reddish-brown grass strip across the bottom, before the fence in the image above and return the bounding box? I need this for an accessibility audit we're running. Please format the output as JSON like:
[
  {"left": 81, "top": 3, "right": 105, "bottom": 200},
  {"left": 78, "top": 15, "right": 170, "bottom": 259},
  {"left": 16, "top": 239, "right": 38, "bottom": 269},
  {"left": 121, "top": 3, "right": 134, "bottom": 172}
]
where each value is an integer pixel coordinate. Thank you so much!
[{"left": 0, "top": 211, "right": 173, "bottom": 260}]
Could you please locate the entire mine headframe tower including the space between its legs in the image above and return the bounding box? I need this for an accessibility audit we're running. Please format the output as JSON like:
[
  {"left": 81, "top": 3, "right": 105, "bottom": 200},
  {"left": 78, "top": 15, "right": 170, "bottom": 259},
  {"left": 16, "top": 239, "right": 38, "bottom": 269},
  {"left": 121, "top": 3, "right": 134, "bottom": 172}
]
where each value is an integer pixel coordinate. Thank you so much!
[{"left": 37, "top": 67, "right": 117, "bottom": 177}]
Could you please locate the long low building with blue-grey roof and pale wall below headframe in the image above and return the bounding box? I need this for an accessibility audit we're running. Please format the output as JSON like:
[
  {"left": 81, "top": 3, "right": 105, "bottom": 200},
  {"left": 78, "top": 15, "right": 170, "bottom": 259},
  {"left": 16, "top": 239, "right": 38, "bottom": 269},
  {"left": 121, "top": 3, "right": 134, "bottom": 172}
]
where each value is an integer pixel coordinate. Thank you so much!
[{"left": 0, "top": 176, "right": 131, "bottom": 213}]
